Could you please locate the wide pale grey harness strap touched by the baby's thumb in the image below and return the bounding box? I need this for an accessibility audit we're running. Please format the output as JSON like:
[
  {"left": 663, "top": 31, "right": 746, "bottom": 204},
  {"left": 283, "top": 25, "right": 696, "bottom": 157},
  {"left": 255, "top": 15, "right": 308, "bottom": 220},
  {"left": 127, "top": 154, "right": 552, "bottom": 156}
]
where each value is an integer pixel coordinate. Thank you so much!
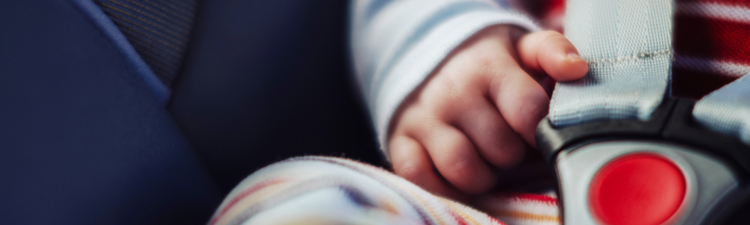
[{"left": 549, "top": 0, "right": 674, "bottom": 127}]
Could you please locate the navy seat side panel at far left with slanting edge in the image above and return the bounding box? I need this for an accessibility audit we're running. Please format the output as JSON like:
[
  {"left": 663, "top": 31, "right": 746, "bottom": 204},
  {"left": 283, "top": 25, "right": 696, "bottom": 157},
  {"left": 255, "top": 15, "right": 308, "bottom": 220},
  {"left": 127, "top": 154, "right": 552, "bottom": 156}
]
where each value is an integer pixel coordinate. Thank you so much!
[{"left": 0, "top": 0, "right": 222, "bottom": 224}]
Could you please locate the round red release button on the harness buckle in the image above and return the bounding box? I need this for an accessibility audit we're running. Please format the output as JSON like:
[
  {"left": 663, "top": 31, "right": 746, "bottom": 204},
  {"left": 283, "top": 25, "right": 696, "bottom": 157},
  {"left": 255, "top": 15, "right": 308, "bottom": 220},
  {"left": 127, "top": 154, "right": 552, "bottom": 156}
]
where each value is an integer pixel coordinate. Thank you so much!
[{"left": 589, "top": 153, "right": 686, "bottom": 225}]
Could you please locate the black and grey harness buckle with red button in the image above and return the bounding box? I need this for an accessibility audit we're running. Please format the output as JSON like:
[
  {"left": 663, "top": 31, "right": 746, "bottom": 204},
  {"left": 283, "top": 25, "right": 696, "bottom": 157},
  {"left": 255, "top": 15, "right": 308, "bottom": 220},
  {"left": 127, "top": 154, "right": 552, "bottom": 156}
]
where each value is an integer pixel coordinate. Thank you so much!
[{"left": 536, "top": 97, "right": 750, "bottom": 225}]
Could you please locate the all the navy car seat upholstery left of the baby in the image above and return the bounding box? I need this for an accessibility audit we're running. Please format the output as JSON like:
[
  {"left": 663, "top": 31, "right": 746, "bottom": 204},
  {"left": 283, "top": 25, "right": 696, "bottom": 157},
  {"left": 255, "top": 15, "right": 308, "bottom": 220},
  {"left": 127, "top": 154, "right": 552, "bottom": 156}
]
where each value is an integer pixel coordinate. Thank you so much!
[{"left": 0, "top": 0, "right": 380, "bottom": 224}]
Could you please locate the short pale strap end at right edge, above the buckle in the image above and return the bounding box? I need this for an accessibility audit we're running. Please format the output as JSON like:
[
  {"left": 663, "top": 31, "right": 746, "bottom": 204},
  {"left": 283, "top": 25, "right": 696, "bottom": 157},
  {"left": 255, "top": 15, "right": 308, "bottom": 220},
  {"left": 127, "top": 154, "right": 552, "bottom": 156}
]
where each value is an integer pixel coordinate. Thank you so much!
[{"left": 693, "top": 75, "right": 750, "bottom": 145}]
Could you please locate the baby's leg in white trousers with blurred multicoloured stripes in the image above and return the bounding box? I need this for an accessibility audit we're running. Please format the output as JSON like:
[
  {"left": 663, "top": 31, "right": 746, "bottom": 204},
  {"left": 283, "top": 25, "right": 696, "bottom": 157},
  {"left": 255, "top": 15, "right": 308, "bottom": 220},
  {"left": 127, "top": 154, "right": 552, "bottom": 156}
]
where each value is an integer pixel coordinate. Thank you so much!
[{"left": 209, "top": 157, "right": 560, "bottom": 225}]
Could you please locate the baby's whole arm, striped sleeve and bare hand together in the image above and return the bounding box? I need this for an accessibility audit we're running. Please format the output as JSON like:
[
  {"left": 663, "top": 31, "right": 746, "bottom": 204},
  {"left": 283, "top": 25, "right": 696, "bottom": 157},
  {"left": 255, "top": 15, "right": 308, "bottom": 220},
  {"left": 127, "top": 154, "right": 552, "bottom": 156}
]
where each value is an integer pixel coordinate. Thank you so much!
[{"left": 351, "top": 0, "right": 588, "bottom": 200}]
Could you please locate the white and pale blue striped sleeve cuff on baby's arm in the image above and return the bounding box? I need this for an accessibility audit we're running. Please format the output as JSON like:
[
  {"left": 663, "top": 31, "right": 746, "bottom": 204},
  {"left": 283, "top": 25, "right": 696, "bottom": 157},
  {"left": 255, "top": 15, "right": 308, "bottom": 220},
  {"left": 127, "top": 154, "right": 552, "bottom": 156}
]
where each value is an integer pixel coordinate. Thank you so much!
[{"left": 349, "top": 0, "right": 538, "bottom": 157}]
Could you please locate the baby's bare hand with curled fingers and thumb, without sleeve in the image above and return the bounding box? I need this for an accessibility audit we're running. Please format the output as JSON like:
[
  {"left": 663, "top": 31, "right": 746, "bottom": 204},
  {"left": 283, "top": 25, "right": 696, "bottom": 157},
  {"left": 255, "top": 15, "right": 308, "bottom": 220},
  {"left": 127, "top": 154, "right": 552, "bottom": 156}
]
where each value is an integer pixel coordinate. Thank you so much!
[{"left": 389, "top": 25, "right": 588, "bottom": 198}]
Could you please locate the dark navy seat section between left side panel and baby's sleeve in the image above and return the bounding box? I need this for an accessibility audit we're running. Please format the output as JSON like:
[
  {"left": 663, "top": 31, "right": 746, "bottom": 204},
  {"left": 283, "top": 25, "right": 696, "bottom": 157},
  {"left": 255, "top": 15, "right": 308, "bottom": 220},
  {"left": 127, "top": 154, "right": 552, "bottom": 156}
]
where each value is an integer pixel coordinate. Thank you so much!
[{"left": 168, "top": 0, "right": 381, "bottom": 192}]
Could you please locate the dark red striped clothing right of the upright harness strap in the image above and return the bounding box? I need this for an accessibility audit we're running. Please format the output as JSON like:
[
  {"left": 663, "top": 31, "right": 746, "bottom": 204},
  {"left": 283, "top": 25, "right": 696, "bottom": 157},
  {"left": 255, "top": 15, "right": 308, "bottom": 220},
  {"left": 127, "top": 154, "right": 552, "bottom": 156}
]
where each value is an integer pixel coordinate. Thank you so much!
[{"left": 672, "top": 0, "right": 750, "bottom": 99}]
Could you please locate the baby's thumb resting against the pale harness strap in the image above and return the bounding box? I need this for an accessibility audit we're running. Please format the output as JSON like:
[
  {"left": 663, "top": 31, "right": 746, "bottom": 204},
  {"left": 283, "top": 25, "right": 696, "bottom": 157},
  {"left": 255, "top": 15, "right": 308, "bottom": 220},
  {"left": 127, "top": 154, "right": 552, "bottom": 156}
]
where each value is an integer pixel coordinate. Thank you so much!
[{"left": 516, "top": 31, "right": 589, "bottom": 81}]
